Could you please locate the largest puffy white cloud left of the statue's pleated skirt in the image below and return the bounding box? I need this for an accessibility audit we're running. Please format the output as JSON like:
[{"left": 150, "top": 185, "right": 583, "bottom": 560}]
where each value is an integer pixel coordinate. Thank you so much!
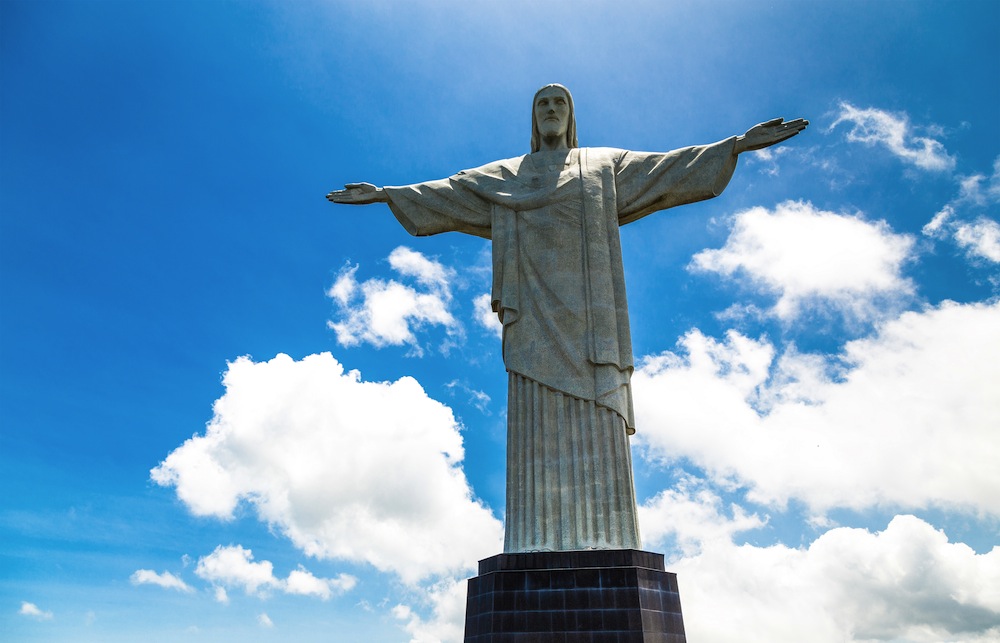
[{"left": 151, "top": 353, "right": 502, "bottom": 583}]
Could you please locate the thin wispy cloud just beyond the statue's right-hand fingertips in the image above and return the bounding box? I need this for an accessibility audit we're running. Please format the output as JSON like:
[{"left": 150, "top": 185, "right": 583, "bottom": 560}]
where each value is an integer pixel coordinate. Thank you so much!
[{"left": 830, "top": 103, "right": 955, "bottom": 171}]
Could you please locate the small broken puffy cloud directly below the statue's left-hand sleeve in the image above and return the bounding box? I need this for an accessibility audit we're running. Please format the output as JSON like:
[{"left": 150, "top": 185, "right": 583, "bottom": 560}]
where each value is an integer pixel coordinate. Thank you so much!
[{"left": 327, "top": 246, "right": 462, "bottom": 355}]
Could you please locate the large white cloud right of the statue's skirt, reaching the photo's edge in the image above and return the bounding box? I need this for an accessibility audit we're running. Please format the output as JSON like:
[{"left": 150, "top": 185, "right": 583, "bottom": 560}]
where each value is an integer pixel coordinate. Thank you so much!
[{"left": 633, "top": 302, "right": 1000, "bottom": 515}]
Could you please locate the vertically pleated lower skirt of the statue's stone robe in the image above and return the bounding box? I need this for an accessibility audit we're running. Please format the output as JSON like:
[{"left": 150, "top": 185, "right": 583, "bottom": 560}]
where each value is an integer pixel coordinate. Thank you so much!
[{"left": 504, "top": 373, "right": 639, "bottom": 553}]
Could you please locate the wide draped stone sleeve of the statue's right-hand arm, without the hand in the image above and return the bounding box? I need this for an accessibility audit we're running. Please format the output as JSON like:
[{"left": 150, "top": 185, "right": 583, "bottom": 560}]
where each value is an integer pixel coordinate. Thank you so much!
[{"left": 615, "top": 136, "right": 737, "bottom": 225}]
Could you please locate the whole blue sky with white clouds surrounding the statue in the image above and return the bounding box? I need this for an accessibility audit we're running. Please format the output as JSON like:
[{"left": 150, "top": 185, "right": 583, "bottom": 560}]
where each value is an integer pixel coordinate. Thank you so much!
[{"left": 0, "top": 0, "right": 1000, "bottom": 642}]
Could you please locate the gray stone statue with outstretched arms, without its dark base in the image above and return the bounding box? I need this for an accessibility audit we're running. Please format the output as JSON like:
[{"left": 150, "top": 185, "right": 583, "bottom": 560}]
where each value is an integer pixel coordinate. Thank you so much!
[{"left": 327, "top": 85, "right": 809, "bottom": 553}]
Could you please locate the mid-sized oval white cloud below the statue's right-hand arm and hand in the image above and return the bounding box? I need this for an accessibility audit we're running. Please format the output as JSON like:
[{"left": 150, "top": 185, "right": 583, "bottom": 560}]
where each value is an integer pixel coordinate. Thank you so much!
[{"left": 691, "top": 201, "right": 913, "bottom": 320}]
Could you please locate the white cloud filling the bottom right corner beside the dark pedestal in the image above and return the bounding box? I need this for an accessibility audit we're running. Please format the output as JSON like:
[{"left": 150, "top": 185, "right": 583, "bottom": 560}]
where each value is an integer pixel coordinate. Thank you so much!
[{"left": 640, "top": 481, "right": 1000, "bottom": 643}]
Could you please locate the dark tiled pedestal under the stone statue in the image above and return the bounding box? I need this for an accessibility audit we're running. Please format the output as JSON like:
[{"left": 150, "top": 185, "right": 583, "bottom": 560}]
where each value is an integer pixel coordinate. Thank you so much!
[{"left": 465, "top": 549, "right": 686, "bottom": 643}]
